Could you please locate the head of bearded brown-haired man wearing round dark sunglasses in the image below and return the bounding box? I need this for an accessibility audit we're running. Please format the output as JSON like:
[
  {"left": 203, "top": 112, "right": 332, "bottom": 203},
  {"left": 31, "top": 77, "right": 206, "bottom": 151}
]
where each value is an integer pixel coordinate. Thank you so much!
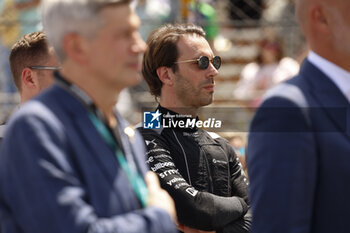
[{"left": 142, "top": 24, "right": 221, "bottom": 108}]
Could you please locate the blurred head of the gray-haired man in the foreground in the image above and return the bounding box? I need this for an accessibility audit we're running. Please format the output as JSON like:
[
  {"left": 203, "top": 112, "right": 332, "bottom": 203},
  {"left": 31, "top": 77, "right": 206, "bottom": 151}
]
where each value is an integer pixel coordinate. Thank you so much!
[{"left": 42, "top": 0, "right": 145, "bottom": 92}]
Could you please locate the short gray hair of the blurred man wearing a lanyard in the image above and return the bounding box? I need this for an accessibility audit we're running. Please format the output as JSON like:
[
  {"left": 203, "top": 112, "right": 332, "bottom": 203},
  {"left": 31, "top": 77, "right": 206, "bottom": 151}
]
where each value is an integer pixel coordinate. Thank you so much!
[{"left": 42, "top": 0, "right": 131, "bottom": 62}]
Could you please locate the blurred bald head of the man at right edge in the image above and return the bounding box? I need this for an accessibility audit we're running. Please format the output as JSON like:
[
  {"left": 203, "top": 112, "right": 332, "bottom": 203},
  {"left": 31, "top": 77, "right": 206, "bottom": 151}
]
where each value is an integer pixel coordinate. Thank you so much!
[{"left": 296, "top": 0, "right": 350, "bottom": 71}]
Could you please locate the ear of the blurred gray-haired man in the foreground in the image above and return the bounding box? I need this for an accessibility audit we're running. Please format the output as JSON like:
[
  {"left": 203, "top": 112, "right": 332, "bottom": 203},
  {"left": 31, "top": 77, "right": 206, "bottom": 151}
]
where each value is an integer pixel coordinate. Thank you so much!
[{"left": 62, "top": 33, "right": 87, "bottom": 64}]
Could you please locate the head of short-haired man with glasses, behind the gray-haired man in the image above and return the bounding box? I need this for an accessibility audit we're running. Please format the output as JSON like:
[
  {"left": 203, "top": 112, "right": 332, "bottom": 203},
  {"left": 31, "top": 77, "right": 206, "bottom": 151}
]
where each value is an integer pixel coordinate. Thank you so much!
[{"left": 9, "top": 32, "right": 58, "bottom": 103}]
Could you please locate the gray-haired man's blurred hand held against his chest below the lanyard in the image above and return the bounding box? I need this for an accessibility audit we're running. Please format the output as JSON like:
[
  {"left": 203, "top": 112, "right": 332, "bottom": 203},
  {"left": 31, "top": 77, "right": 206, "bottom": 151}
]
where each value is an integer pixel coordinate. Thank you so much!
[{"left": 145, "top": 171, "right": 177, "bottom": 222}]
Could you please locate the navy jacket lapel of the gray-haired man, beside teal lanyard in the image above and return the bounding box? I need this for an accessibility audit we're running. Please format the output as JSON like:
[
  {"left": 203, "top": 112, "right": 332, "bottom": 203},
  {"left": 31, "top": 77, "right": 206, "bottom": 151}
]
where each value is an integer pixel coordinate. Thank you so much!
[{"left": 52, "top": 86, "right": 145, "bottom": 211}]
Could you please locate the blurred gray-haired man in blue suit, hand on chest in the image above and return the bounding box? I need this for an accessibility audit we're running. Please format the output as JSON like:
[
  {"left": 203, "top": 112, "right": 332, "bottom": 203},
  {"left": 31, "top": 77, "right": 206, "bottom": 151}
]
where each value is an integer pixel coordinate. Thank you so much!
[{"left": 0, "top": 0, "right": 176, "bottom": 233}]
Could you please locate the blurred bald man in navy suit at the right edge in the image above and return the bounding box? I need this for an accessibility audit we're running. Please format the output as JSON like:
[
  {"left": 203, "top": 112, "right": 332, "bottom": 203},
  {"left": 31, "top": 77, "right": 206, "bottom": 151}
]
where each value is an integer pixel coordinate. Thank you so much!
[{"left": 247, "top": 0, "right": 350, "bottom": 233}]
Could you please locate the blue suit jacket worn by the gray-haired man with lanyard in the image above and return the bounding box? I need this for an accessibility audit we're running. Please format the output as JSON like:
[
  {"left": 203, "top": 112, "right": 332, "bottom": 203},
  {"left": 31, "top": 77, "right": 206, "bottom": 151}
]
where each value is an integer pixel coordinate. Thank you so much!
[{"left": 0, "top": 85, "right": 176, "bottom": 233}]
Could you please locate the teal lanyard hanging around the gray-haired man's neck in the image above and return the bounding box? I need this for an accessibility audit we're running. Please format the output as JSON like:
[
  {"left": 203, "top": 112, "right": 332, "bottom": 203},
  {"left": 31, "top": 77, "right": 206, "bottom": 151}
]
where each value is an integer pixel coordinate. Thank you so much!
[{"left": 89, "top": 112, "right": 148, "bottom": 207}]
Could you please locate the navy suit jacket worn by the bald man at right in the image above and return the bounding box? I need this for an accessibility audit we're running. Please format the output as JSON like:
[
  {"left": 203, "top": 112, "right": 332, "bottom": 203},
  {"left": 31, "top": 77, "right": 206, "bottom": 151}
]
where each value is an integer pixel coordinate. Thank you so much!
[{"left": 247, "top": 60, "right": 350, "bottom": 233}]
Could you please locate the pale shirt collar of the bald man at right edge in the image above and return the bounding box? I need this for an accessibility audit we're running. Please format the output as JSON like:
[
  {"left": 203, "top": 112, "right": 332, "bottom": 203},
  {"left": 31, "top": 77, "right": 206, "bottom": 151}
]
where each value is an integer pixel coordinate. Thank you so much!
[{"left": 307, "top": 51, "right": 350, "bottom": 102}]
